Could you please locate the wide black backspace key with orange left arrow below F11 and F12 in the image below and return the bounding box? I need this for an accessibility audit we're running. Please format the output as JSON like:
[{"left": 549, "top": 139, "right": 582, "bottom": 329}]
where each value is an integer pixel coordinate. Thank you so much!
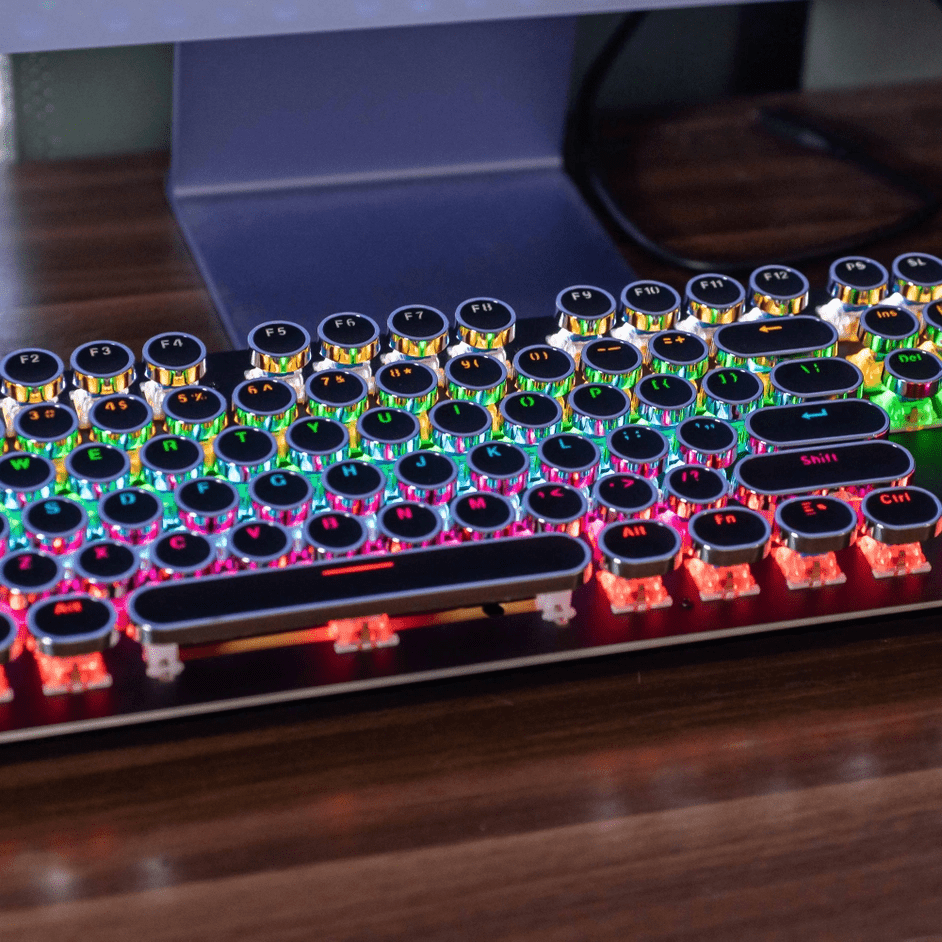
[{"left": 713, "top": 314, "right": 837, "bottom": 368}]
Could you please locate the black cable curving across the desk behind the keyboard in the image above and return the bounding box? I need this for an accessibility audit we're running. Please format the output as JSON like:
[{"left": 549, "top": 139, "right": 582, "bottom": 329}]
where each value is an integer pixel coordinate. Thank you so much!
[{"left": 564, "top": 11, "right": 942, "bottom": 272}]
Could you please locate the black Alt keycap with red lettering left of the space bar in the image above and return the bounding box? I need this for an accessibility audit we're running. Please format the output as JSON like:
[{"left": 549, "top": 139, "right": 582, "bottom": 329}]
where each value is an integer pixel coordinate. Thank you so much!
[{"left": 26, "top": 593, "right": 117, "bottom": 657}]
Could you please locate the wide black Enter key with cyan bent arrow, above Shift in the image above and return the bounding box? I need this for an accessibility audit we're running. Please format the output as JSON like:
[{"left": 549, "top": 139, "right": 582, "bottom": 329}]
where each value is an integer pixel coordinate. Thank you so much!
[{"left": 746, "top": 399, "right": 890, "bottom": 454}]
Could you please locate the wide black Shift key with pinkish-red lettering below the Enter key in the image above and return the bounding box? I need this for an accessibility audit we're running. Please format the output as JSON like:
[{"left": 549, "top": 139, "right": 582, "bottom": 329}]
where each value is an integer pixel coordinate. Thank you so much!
[{"left": 734, "top": 440, "right": 915, "bottom": 510}]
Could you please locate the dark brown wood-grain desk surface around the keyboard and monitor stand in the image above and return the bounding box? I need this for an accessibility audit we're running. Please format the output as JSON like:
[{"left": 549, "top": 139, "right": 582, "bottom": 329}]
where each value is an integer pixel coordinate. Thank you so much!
[{"left": 0, "top": 85, "right": 942, "bottom": 942}]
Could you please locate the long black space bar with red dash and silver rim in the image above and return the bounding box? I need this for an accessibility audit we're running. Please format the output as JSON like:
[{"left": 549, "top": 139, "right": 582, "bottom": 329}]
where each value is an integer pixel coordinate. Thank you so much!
[{"left": 128, "top": 533, "right": 591, "bottom": 644}]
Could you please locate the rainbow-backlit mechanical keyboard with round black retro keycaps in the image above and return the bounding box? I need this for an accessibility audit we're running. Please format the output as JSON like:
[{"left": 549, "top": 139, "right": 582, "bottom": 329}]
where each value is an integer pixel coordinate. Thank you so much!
[{"left": 0, "top": 253, "right": 942, "bottom": 741}]
